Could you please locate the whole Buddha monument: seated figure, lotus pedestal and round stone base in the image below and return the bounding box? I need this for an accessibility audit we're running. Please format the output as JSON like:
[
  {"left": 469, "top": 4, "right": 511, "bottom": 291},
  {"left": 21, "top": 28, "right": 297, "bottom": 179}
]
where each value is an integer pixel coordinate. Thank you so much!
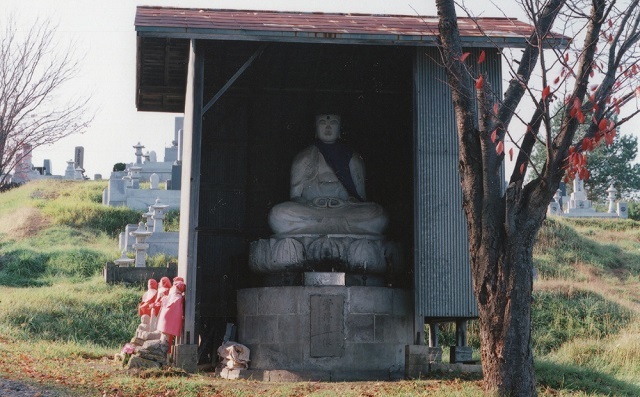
[{"left": 235, "top": 114, "right": 413, "bottom": 380}]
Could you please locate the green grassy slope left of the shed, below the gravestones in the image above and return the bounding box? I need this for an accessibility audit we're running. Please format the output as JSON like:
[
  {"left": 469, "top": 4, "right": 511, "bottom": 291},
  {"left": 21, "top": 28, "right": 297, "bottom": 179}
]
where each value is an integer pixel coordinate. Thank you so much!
[{"left": 0, "top": 180, "right": 147, "bottom": 348}]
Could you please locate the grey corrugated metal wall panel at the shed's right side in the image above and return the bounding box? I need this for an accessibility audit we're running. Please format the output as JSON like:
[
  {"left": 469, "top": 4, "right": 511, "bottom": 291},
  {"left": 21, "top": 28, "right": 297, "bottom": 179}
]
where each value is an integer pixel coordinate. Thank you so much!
[{"left": 414, "top": 48, "right": 501, "bottom": 320}]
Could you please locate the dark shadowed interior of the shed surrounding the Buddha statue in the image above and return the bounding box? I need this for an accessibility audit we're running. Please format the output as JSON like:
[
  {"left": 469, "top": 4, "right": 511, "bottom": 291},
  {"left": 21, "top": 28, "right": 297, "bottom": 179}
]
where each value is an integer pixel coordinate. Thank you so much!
[{"left": 196, "top": 40, "right": 415, "bottom": 362}]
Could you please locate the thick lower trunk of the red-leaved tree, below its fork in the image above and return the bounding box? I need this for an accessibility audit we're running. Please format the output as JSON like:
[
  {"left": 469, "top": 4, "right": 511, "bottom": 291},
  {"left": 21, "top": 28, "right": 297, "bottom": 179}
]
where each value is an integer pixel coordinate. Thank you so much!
[{"left": 470, "top": 183, "right": 548, "bottom": 396}]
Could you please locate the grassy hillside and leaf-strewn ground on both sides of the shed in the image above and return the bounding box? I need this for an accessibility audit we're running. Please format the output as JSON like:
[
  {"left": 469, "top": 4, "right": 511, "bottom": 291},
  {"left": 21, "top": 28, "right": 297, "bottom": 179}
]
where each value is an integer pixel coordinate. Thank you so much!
[{"left": 0, "top": 181, "right": 640, "bottom": 396}]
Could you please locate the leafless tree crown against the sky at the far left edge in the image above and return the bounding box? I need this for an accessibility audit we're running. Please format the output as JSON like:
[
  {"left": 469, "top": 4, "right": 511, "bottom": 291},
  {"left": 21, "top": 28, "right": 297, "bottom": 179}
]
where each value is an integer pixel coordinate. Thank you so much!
[{"left": 0, "top": 16, "right": 93, "bottom": 184}]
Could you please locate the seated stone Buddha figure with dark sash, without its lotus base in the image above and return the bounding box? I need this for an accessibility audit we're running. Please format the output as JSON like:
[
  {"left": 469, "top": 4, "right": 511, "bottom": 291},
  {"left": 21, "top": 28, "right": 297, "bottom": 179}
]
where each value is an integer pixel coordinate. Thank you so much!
[{"left": 269, "top": 114, "right": 387, "bottom": 236}]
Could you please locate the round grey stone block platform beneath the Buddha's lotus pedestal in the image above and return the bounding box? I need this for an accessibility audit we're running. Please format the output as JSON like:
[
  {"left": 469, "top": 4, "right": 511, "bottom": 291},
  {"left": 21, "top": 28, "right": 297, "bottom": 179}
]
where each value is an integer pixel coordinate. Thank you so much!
[{"left": 238, "top": 286, "right": 413, "bottom": 380}]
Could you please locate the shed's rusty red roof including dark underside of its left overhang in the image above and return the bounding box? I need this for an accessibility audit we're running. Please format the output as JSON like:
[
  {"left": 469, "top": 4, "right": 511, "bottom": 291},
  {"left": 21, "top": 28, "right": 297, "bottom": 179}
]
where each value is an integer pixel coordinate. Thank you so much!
[{"left": 135, "top": 6, "right": 568, "bottom": 112}]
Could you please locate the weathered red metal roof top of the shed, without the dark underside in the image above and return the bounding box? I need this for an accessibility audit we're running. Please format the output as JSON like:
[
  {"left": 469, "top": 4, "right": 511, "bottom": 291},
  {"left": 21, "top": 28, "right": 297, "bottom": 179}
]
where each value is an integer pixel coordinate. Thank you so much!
[{"left": 135, "top": 6, "right": 566, "bottom": 47}]
